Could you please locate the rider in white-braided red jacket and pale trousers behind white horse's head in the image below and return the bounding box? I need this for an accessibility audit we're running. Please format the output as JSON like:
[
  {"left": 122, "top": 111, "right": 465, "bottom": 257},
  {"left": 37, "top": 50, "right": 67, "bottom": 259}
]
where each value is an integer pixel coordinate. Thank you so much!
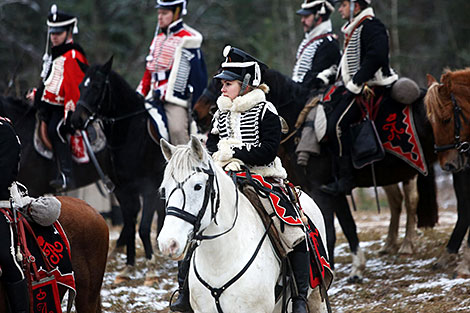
[{"left": 137, "top": 0, "right": 207, "bottom": 144}]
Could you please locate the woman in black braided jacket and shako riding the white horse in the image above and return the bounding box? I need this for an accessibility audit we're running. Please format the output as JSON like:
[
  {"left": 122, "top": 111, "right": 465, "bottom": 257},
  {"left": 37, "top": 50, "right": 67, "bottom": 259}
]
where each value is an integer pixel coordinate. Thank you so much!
[{"left": 206, "top": 46, "right": 309, "bottom": 313}]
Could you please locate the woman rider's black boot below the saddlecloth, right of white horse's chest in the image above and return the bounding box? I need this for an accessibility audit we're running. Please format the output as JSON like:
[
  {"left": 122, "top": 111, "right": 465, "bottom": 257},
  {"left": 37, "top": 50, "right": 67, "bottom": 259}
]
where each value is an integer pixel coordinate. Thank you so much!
[{"left": 288, "top": 250, "right": 310, "bottom": 313}]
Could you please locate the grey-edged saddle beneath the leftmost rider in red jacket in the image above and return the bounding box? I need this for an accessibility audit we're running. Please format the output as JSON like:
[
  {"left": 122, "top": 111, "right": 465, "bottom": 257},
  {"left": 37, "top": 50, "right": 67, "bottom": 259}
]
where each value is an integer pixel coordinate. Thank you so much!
[{"left": 33, "top": 118, "right": 106, "bottom": 163}]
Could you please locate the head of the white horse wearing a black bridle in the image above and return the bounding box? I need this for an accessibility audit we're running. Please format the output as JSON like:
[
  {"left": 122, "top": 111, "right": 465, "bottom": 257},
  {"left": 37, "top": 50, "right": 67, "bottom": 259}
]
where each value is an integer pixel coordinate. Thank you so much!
[{"left": 158, "top": 136, "right": 218, "bottom": 259}]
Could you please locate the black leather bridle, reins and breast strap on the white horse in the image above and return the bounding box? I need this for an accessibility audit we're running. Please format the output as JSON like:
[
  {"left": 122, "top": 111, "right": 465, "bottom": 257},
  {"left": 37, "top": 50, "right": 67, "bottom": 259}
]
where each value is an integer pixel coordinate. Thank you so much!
[{"left": 166, "top": 163, "right": 269, "bottom": 313}]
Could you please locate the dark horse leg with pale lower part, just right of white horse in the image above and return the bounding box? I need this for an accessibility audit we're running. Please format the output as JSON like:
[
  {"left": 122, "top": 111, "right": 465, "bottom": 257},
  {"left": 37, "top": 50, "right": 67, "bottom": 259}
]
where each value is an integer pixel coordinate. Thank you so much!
[{"left": 336, "top": 196, "right": 366, "bottom": 283}]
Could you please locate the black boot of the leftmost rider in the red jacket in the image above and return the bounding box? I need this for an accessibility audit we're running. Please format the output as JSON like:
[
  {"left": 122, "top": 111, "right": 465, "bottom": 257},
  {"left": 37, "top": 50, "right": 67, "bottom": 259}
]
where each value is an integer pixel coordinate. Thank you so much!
[{"left": 49, "top": 139, "right": 75, "bottom": 192}]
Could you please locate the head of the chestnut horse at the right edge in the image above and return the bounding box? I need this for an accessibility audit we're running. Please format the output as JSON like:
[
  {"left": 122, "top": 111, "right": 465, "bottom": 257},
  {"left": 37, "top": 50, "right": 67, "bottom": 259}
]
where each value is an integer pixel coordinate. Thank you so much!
[{"left": 424, "top": 69, "right": 470, "bottom": 172}]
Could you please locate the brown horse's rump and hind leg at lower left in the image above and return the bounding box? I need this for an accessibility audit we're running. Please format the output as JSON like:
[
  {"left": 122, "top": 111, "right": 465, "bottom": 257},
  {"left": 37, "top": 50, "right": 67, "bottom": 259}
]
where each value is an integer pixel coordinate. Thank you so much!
[{"left": 0, "top": 197, "right": 109, "bottom": 313}]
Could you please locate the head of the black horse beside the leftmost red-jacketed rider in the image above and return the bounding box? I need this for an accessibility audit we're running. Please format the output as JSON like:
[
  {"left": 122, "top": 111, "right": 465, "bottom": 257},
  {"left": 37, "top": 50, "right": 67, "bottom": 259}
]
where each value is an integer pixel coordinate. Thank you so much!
[{"left": 72, "top": 56, "right": 113, "bottom": 129}]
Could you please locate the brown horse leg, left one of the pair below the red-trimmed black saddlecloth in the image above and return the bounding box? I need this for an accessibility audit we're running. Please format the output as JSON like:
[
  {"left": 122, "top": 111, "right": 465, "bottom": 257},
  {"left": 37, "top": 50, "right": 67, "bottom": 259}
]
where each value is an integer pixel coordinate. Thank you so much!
[{"left": 379, "top": 184, "right": 403, "bottom": 254}]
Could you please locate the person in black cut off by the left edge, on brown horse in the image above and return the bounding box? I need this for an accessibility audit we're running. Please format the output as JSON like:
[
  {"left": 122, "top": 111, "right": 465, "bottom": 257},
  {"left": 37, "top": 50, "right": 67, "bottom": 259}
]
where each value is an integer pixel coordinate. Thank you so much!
[{"left": 0, "top": 117, "right": 29, "bottom": 313}]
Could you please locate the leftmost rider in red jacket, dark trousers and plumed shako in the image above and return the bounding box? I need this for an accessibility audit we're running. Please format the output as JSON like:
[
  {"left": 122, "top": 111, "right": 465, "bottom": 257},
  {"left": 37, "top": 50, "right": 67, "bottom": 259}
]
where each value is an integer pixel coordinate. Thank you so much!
[{"left": 34, "top": 4, "right": 88, "bottom": 191}]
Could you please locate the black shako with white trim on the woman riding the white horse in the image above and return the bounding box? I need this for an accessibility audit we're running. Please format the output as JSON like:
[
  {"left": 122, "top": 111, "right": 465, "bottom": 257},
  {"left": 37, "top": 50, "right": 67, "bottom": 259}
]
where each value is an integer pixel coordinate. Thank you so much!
[{"left": 214, "top": 46, "right": 268, "bottom": 87}]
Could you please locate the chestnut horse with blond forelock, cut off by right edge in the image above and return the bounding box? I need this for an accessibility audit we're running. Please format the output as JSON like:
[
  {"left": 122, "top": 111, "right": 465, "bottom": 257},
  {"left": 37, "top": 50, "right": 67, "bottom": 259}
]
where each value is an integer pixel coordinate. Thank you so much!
[{"left": 424, "top": 69, "right": 470, "bottom": 277}]
